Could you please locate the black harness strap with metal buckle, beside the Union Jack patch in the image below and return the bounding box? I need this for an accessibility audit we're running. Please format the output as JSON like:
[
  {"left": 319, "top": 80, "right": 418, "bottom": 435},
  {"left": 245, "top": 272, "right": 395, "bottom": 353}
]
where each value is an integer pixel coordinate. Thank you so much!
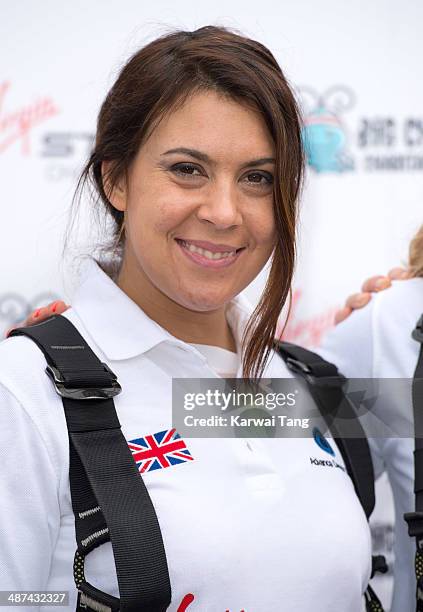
[{"left": 9, "top": 315, "right": 171, "bottom": 612}]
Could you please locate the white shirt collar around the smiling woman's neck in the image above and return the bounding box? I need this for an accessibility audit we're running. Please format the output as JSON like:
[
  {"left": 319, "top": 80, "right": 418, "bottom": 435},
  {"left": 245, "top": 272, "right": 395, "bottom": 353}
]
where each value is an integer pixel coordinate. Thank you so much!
[{"left": 72, "top": 258, "right": 252, "bottom": 361}]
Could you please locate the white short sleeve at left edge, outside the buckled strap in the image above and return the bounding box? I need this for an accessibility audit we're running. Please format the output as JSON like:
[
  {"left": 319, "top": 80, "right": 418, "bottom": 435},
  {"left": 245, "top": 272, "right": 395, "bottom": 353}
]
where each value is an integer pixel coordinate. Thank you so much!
[{"left": 0, "top": 384, "right": 60, "bottom": 592}]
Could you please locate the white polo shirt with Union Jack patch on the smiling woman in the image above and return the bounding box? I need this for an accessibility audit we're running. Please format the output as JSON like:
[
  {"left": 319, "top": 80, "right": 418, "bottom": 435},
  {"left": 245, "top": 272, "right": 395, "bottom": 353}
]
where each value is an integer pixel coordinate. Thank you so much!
[{"left": 0, "top": 262, "right": 371, "bottom": 612}]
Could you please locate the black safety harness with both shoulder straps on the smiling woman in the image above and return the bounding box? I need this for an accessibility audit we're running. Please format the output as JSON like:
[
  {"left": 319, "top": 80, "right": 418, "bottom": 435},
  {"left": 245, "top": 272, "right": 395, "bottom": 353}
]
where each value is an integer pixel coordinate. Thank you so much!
[{"left": 9, "top": 315, "right": 388, "bottom": 612}]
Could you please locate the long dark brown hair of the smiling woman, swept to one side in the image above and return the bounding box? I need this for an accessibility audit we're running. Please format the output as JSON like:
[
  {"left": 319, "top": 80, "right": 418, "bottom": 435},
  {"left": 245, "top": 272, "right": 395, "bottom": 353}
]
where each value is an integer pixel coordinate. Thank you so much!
[{"left": 68, "top": 26, "right": 304, "bottom": 381}]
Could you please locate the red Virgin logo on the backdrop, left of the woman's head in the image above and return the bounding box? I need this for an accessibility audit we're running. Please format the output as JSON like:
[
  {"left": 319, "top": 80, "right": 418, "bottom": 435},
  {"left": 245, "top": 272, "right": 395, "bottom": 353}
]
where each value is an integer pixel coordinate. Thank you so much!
[{"left": 0, "top": 81, "right": 59, "bottom": 155}]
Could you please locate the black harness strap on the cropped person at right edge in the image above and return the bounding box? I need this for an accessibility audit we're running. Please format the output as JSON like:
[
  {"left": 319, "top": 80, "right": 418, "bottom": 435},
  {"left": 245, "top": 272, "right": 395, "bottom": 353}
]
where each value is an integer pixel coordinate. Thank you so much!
[{"left": 404, "top": 315, "right": 423, "bottom": 612}]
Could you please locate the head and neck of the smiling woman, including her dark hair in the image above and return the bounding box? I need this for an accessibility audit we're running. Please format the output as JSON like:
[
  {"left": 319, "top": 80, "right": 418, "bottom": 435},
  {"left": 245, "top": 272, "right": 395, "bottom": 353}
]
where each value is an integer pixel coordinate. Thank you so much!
[{"left": 70, "top": 26, "right": 304, "bottom": 378}]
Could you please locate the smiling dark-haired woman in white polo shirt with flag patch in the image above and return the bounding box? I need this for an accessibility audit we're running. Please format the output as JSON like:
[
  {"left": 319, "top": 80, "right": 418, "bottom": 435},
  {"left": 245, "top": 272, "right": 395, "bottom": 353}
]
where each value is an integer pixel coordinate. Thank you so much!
[{"left": 0, "top": 26, "right": 371, "bottom": 612}]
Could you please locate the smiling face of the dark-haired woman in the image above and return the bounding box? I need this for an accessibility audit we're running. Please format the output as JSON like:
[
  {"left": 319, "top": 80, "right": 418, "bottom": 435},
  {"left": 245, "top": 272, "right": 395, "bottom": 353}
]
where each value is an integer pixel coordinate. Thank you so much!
[{"left": 110, "top": 92, "right": 276, "bottom": 311}]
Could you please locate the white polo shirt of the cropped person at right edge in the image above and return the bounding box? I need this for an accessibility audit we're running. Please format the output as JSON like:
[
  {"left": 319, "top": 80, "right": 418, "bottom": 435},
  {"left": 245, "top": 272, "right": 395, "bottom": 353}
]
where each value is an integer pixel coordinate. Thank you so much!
[{"left": 314, "top": 278, "right": 423, "bottom": 612}]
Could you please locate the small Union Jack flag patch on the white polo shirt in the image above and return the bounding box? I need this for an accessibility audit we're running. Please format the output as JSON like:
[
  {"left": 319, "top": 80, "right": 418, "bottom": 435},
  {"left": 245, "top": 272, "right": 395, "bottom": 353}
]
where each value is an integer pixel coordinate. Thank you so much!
[{"left": 128, "top": 429, "right": 194, "bottom": 474}]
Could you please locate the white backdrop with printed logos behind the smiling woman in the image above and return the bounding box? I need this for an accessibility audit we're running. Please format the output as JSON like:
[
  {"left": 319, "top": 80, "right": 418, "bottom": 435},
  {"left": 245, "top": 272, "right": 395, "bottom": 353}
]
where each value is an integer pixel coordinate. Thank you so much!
[{"left": 0, "top": 0, "right": 423, "bottom": 608}]
